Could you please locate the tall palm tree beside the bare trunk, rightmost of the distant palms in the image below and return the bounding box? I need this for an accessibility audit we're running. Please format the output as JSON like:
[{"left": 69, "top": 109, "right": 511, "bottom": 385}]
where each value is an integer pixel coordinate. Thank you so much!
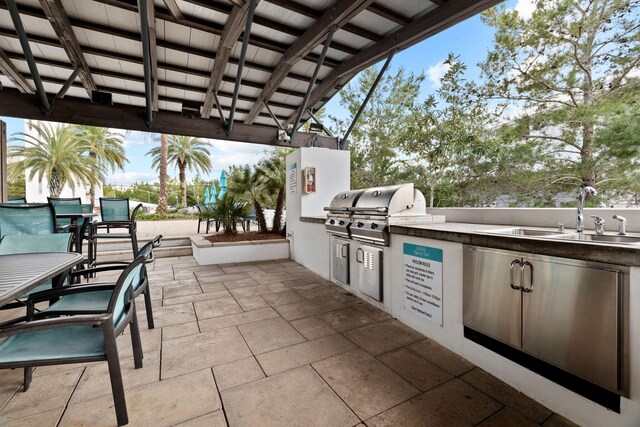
[{"left": 147, "top": 135, "right": 211, "bottom": 207}]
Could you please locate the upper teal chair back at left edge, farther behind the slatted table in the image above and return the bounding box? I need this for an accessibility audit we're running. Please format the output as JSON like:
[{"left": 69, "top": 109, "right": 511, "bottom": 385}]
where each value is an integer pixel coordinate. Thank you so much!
[{"left": 0, "top": 203, "right": 57, "bottom": 236}]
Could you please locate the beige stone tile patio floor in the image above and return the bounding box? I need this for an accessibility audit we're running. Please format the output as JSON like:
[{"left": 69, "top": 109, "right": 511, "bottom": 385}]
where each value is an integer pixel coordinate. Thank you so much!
[{"left": 0, "top": 257, "right": 573, "bottom": 427}]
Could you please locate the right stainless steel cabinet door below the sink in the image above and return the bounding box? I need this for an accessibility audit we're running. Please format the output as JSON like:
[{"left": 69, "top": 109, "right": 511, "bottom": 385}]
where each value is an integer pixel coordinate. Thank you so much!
[{"left": 522, "top": 257, "right": 622, "bottom": 391}]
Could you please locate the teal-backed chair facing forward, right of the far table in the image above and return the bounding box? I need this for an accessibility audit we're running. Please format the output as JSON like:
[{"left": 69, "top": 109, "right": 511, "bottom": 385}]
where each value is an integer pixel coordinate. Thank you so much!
[{"left": 89, "top": 197, "right": 142, "bottom": 262}]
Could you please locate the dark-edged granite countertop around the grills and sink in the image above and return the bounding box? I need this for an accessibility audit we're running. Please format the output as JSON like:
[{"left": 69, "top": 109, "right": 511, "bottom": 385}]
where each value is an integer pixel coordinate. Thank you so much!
[{"left": 300, "top": 216, "right": 640, "bottom": 267}]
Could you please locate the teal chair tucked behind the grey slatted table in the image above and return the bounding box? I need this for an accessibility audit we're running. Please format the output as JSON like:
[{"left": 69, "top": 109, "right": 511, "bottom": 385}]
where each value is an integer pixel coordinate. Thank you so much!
[{"left": 0, "top": 233, "right": 71, "bottom": 310}]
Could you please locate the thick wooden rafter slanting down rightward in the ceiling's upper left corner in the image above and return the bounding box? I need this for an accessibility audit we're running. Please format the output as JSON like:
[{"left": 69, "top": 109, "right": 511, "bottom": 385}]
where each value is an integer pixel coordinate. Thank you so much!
[{"left": 40, "top": 0, "right": 96, "bottom": 97}]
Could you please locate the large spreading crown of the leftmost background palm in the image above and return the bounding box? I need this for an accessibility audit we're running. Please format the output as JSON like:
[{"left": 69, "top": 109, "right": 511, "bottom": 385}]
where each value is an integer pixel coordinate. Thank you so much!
[{"left": 9, "top": 123, "right": 105, "bottom": 197}]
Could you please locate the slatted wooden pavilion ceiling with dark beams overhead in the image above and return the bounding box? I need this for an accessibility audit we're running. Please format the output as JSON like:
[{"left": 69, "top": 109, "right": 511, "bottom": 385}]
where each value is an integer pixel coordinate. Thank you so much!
[{"left": 0, "top": 0, "right": 501, "bottom": 148}]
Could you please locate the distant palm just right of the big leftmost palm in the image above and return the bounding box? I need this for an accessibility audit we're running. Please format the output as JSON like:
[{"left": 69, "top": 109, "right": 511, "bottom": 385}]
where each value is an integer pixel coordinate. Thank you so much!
[{"left": 76, "top": 126, "right": 129, "bottom": 205}]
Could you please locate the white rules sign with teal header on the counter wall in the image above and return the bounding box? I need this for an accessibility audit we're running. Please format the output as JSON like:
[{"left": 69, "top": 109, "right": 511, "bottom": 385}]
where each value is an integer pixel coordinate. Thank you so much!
[{"left": 403, "top": 243, "right": 442, "bottom": 326}]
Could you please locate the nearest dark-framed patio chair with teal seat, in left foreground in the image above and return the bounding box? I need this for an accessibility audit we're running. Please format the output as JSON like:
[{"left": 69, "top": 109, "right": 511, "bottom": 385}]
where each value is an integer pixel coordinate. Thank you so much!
[{"left": 0, "top": 254, "right": 144, "bottom": 425}]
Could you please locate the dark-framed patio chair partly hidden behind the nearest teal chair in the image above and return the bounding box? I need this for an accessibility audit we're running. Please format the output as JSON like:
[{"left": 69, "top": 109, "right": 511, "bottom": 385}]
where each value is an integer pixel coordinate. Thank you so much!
[{"left": 71, "top": 235, "right": 162, "bottom": 329}]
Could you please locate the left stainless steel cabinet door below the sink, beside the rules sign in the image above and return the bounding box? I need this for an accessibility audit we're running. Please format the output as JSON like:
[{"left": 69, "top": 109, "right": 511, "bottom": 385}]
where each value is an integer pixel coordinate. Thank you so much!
[{"left": 463, "top": 246, "right": 522, "bottom": 348}]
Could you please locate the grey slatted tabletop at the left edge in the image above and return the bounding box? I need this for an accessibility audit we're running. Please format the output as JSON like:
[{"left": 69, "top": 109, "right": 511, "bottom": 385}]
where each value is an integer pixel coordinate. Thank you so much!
[{"left": 0, "top": 252, "right": 82, "bottom": 307}]
